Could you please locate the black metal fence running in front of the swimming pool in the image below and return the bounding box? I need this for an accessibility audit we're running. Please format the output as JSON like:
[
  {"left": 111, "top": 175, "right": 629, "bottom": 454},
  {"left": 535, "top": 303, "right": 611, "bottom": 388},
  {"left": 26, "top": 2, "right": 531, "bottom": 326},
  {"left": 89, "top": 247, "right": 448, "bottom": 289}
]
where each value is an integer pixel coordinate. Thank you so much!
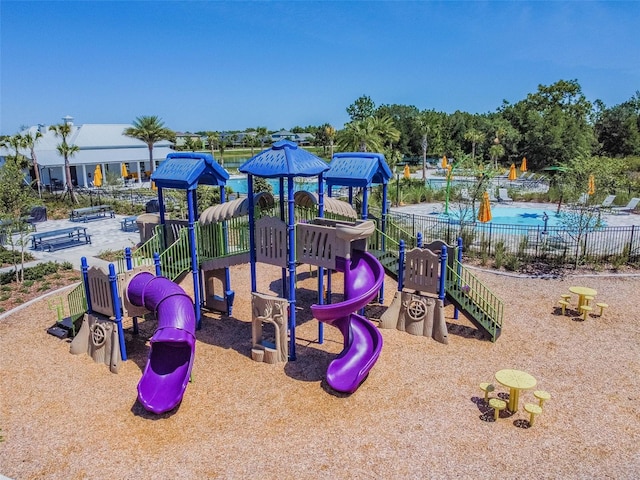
[{"left": 372, "top": 210, "right": 640, "bottom": 267}]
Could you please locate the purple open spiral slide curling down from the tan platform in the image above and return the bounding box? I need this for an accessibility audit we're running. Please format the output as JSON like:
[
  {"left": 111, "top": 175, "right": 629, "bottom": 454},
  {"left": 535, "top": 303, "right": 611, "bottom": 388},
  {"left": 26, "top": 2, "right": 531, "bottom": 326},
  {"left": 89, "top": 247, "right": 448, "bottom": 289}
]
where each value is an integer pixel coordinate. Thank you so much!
[{"left": 311, "top": 251, "right": 384, "bottom": 393}]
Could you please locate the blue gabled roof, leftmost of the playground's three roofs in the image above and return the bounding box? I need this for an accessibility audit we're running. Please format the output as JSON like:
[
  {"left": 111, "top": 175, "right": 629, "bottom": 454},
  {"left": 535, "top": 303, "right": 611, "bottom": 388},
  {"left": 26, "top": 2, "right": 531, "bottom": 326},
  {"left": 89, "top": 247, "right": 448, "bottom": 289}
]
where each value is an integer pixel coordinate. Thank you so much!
[{"left": 151, "top": 152, "right": 229, "bottom": 190}]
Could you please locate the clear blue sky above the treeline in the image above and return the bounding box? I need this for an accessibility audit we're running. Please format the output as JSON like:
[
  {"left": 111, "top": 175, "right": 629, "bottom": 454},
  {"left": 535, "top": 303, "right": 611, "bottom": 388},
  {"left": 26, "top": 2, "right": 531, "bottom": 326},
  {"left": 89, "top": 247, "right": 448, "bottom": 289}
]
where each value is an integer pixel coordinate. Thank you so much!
[{"left": 0, "top": 0, "right": 640, "bottom": 134}]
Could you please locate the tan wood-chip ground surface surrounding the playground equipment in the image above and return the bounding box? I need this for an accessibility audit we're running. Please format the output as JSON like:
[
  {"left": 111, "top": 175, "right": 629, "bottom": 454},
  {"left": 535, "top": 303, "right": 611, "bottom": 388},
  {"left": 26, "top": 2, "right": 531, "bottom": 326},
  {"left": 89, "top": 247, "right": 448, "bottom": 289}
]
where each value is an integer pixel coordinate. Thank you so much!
[{"left": 0, "top": 266, "right": 640, "bottom": 479}]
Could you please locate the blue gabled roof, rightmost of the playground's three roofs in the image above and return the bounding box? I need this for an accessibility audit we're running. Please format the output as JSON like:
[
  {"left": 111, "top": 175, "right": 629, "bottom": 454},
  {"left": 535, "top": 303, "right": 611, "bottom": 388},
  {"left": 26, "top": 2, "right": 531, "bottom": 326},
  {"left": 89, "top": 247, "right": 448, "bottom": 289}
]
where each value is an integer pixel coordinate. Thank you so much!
[{"left": 324, "top": 152, "right": 393, "bottom": 187}]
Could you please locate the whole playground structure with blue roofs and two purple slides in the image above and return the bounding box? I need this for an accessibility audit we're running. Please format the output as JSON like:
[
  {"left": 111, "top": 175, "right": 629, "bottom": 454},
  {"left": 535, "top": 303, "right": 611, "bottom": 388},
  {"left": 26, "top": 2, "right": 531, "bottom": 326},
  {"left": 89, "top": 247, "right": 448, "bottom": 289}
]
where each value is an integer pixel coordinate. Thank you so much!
[{"left": 57, "top": 141, "right": 502, "bottom": 413}]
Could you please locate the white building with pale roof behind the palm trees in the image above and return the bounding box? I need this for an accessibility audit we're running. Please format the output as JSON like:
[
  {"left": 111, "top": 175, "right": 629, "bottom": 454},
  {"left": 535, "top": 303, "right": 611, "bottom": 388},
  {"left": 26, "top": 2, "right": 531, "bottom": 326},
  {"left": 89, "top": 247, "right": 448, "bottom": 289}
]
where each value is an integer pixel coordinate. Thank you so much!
[{"left": 0, "top": 117, "right": 174, "bottom": 187}]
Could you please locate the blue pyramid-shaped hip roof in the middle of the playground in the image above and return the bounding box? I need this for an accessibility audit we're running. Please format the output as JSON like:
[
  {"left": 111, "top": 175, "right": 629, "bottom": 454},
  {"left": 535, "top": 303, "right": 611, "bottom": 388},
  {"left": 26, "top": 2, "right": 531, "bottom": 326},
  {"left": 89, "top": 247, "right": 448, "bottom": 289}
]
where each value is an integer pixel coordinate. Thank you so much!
[{"left": 238, "top": 140, "right": 329, "bottom": 178}]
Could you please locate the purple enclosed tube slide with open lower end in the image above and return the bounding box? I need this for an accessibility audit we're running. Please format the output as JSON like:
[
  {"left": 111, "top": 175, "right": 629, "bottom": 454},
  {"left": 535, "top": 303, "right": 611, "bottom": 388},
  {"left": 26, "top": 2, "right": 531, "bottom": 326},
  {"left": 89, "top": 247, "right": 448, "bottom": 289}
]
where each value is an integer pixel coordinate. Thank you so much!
[{"left": 127, "top": 272, "right": 196, "bottom": 414}]
